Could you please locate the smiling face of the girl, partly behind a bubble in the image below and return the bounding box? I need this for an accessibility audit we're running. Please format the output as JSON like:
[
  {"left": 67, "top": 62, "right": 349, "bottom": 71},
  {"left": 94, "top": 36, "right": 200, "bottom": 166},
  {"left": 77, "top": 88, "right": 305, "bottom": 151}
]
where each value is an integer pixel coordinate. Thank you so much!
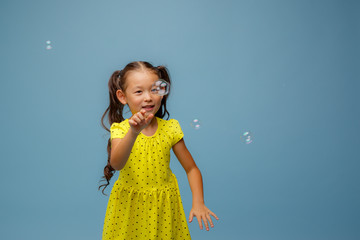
[{"left": 116, "top": 71, "right": 163, "bottom": 115}]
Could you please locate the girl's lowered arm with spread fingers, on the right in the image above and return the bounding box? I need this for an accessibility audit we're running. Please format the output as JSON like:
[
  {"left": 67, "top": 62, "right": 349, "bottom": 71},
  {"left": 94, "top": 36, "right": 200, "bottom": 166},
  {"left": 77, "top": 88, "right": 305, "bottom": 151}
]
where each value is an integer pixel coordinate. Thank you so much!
[{"left": 173, "top": 139, "right": 219, "bottom": 231}]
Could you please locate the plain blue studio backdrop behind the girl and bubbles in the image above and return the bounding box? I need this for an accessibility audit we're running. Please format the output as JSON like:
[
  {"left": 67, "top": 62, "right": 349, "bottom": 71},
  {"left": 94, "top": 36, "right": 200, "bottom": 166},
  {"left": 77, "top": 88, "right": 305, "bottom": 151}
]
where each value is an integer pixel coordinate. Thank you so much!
[{"left": 0, "top": 0, "right": 360, "bottom": 240}]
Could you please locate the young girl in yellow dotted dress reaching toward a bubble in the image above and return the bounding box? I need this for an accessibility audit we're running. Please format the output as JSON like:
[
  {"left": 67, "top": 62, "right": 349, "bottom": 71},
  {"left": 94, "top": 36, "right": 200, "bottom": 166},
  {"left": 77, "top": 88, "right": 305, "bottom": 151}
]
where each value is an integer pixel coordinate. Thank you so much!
[{"left": 99, "top": 62, "right": 219, "bottom": 240}]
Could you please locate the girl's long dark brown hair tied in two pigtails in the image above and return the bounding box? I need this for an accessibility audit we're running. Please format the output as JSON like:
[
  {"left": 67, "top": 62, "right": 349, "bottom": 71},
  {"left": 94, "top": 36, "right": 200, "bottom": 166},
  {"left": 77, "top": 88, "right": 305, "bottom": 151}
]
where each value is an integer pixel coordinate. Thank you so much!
[{"left": 98, "top": 61, "right": 171, "bottom": 195}]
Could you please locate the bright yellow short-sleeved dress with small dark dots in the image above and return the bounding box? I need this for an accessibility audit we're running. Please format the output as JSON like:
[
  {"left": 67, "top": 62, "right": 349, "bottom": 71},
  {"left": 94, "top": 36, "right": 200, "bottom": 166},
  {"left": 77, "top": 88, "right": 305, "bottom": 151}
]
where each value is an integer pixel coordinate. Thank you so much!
[{"left": 102, "top": 117, "right": 191, "bottom": 240}]
